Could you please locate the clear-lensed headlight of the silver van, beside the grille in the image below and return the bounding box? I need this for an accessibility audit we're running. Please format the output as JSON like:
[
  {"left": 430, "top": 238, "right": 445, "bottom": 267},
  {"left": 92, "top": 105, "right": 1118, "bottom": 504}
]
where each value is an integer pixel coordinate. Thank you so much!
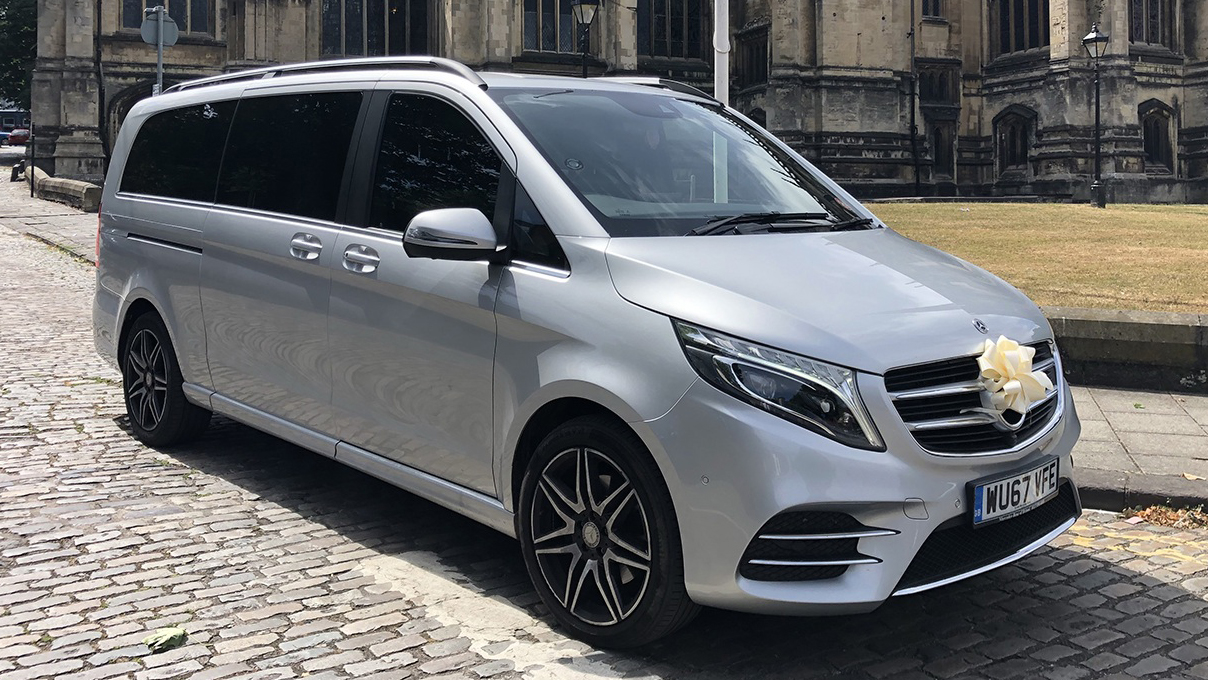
[{"left": 675, "top": 321, "right": 885, "bottom": 451}]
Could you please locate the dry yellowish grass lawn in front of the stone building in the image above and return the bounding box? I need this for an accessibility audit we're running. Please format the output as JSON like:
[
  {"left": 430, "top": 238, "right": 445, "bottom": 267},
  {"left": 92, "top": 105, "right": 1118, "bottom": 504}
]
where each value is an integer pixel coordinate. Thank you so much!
[{"left": 867, "top": 203, "right": 1208, "bottom": 313}]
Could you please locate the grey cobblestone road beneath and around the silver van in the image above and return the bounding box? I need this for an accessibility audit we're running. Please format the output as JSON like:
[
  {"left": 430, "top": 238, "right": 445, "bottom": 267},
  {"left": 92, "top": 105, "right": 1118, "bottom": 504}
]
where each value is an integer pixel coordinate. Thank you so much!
[{"left": 0, "top": 205, "right": 1208, "bottom": 680}]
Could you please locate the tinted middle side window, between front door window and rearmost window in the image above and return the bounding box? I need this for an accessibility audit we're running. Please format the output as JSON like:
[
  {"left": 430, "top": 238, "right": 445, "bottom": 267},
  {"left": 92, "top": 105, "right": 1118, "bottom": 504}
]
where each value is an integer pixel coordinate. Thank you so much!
[{"left": 217, "top": 92, "right": 361, "bottom": 221}]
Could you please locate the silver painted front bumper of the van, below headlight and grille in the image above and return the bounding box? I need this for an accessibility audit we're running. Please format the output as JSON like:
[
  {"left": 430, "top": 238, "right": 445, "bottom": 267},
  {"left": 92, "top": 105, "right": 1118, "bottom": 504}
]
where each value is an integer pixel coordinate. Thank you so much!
[{"left": 643, "top": 377, "right": 1081, "bottom": 615}]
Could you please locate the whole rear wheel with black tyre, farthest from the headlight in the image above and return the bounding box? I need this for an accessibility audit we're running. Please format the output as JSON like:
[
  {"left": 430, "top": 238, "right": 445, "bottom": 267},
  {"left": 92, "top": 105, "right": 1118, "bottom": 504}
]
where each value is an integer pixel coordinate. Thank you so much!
[{"left": 121, "top": 312, "right": 210, "bottom": 447}]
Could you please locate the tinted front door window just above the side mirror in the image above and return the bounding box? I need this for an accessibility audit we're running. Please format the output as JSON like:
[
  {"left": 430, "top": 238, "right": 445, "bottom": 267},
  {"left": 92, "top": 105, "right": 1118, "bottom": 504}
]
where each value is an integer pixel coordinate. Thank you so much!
[{"left": 370, "top": 94, "right": 501, "bottom": 231}]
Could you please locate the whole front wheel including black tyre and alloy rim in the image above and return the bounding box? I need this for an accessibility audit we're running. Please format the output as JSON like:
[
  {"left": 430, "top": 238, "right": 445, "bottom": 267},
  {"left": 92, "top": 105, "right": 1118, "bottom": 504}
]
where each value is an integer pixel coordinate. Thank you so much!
[{"left": 517, "top": 415, "right": 699, "bottom": 649}]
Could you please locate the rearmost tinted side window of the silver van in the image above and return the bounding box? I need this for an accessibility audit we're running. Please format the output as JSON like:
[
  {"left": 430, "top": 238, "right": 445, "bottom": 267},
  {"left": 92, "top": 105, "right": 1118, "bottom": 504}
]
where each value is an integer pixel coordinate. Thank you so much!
[{"left": 120, "top": 101, "right": 236, "bottom": 203}]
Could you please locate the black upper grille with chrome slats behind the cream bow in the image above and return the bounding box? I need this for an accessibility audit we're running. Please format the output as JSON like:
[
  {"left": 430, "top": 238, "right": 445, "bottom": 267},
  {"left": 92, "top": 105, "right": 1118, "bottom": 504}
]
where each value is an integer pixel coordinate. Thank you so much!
[{"left": 885, "top": 342, "right": 1058, "bottom": 454}]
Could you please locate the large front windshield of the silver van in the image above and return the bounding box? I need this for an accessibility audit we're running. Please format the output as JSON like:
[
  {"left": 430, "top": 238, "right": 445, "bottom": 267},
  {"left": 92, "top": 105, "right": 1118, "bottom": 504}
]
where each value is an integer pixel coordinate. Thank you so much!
[{"left": 488, "top": 88, "right": 859, "bottom": 237}]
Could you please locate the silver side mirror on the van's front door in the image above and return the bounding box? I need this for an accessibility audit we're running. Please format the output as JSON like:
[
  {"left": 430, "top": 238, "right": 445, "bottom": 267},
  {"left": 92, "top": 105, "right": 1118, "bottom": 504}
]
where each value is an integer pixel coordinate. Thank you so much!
[{"left": 402, "top": 208, "right": 498, "bottom": 260}]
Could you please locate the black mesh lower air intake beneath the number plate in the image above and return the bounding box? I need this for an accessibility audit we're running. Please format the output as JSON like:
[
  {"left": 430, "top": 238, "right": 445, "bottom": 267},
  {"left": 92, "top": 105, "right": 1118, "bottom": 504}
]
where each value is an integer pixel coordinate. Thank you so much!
[{"left": 896, "top": 482, "right": 1081, "bottom": 591}]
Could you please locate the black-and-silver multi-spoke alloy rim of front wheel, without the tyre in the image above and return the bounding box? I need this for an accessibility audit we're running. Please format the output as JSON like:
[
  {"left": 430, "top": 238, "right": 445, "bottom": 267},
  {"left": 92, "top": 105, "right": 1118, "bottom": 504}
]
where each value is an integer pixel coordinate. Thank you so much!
[{"left": 532, "top": 448, "right": 652, "bottom": 626}]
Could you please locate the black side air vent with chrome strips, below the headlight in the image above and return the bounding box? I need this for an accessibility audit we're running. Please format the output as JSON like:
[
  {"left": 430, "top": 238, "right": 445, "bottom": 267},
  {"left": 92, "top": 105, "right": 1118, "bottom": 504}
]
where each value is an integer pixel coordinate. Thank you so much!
[{"left": 738, "top": 511, "right": 881, "bottom": 581}]
